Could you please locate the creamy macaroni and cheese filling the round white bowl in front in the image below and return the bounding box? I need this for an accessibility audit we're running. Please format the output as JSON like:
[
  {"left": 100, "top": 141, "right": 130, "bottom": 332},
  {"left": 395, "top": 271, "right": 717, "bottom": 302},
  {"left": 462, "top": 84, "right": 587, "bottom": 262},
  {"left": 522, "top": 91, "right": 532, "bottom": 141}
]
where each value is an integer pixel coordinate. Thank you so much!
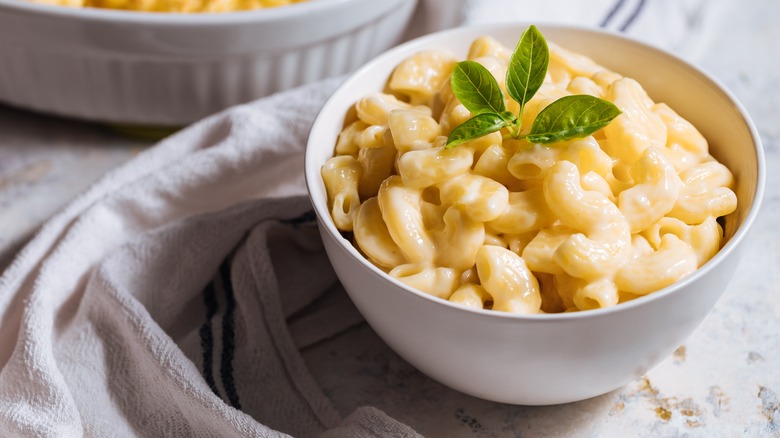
[{"left": 322, "top": 36, "right": 737, "bottom": 314}]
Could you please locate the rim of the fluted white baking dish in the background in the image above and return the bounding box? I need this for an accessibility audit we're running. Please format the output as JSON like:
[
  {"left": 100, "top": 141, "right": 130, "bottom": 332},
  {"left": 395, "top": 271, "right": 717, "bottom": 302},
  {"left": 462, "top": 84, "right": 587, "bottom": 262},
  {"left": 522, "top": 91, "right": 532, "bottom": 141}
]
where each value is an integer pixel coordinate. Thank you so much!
[{"left": 0, "top": 0, "right": 384, "bottom": 26}]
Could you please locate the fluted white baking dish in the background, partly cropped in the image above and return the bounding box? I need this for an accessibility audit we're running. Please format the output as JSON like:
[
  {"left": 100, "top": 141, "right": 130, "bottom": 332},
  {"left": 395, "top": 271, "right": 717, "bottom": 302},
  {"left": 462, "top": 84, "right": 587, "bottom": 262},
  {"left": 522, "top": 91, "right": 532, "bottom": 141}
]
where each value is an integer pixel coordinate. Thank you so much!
[{"left": 0, "top": 0, "right": 417, "bottom": 126}]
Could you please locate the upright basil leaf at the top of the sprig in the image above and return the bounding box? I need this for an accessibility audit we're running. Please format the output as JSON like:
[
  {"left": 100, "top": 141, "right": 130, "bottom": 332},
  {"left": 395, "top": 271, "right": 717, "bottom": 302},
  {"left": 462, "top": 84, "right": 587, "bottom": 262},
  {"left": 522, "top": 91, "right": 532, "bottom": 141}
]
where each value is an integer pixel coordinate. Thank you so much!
[{"left": 506, "top": 26, "right": 550, "bottom": 114}]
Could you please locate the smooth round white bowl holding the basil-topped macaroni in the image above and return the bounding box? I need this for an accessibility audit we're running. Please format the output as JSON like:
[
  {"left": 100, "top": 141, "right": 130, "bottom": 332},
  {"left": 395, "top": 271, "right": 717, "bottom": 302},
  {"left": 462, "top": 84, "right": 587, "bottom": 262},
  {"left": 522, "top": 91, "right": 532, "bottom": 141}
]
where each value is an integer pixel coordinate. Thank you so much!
[{"left": 305, "top": 24, "right": 765, "bottom": 405}]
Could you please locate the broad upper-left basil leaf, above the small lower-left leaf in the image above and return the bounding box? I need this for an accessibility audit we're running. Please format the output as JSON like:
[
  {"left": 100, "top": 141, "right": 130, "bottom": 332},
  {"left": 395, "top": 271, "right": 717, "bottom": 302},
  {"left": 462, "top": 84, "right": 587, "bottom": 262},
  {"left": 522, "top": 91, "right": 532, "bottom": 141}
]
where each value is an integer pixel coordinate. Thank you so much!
[{"left": 450, "top": 61, "right": 506, "bottom": 115}]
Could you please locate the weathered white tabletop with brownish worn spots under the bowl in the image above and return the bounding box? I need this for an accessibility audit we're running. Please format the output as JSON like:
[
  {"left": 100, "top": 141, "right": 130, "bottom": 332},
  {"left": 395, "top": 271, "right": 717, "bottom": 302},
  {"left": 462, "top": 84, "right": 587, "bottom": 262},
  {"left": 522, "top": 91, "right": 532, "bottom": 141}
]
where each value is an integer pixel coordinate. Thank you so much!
[{"left": 0, "top": 0, "right": 780, "bottom": 437}]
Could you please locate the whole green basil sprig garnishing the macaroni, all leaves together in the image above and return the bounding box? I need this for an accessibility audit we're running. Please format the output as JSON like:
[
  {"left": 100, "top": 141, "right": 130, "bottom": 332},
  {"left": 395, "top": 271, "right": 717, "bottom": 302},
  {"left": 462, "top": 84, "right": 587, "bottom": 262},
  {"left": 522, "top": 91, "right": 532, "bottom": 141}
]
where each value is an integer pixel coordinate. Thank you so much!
[{"left": 446, "top": 26, "right": 621, "bottom": 148}]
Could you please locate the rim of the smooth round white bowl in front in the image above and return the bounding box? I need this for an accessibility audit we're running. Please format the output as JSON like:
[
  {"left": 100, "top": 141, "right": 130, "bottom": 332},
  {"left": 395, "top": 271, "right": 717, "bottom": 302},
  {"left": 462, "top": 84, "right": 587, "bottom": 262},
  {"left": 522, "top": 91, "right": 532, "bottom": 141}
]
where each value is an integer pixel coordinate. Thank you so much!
[{"left": 304, "top": 21, "right": 766, "bottom": 322}]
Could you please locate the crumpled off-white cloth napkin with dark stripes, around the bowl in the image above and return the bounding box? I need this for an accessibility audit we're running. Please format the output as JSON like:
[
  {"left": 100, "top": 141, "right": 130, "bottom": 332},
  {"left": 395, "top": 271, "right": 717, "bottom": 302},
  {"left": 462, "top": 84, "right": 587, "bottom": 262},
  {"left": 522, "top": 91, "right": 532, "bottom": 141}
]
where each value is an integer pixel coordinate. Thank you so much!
[{"left": 0, "top": 0, "right": 732, "bottom": 437}]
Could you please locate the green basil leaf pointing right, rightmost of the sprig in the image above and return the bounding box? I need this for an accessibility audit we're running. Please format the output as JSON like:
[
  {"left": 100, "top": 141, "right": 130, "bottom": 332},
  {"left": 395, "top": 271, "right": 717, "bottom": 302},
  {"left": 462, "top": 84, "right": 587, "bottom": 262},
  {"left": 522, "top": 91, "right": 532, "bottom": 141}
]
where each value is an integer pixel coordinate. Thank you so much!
[{"left": 526, "top": 94, "right": 621, "bottom": 143}]
